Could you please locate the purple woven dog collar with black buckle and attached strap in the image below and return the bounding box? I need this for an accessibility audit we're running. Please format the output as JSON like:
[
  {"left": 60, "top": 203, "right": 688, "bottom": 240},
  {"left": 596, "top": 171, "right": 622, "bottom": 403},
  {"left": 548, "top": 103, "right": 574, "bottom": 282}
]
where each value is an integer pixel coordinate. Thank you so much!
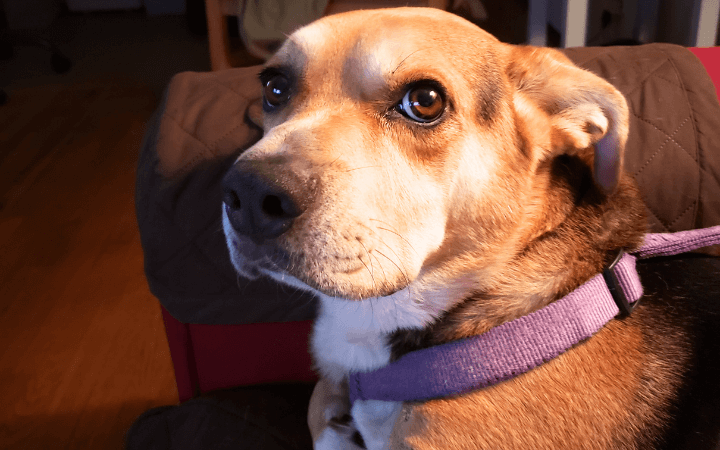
[{"left": 348, "top": 226, "right": 720, "bottom": 403}]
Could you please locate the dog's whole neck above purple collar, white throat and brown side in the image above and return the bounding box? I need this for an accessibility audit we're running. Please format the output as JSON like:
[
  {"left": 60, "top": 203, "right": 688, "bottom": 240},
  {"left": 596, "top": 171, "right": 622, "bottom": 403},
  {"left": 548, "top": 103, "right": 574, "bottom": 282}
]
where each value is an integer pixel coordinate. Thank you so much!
[{"left": 312, "top": 158, "right": 645, "bottom": 382}]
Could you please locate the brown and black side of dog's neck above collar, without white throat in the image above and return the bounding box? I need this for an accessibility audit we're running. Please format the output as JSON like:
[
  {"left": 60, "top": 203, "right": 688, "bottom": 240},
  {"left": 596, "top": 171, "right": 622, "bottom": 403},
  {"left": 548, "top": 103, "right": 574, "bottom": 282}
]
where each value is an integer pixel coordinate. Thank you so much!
[{"left": 390, "top": 158, "right": 646, "bottom": 360}]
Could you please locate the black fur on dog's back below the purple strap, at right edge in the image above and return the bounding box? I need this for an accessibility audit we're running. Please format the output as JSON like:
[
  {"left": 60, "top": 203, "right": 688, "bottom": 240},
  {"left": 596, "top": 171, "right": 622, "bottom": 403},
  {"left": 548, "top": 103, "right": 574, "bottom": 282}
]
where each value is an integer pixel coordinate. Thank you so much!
[{"left": 638, "top": 254, "right": 720, "bottom": 450}]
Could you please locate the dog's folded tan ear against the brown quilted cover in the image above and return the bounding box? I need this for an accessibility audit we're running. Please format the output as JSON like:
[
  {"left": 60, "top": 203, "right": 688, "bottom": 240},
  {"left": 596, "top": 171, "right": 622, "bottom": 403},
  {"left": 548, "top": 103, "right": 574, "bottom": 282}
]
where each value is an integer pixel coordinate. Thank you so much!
[{"left": 507, "top": 46, "right": 628, "bottom": 194}]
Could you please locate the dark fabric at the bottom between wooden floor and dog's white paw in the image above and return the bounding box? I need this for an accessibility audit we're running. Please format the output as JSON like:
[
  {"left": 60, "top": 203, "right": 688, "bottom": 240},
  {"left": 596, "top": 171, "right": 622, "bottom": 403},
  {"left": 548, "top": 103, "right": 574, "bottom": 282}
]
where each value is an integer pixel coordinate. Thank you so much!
[{"left": 125, "top": 384, "right": 313, "bottom": 450}]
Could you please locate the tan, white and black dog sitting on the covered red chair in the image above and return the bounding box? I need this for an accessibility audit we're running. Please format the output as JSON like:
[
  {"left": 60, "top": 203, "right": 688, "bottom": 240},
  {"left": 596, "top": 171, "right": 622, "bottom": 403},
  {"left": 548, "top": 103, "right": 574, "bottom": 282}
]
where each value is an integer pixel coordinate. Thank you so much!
[{"left": 222, "top": 8, "right": 720, "bottom": 449}]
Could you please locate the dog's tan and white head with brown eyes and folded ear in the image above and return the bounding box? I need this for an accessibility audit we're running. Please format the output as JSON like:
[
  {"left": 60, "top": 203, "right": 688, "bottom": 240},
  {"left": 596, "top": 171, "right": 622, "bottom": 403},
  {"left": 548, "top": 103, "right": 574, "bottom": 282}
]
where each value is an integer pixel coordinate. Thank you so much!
[{"left": 223, "top": 8, "right": 640, "bottom": 316}]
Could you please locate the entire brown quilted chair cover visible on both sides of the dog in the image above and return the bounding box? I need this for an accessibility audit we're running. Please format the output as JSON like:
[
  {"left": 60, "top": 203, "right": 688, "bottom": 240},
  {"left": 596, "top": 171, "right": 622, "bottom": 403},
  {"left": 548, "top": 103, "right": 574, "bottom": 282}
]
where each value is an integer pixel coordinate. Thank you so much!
[{"left": 136, "top": 44, "right": 720, "bottom": 324}]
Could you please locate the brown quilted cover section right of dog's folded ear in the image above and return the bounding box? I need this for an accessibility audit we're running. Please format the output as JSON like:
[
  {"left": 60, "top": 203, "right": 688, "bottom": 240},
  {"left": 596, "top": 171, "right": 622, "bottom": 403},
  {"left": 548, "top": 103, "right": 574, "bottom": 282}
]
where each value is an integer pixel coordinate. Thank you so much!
[{"left": 565, "top": 44, "right": 720, "bottom": 233}]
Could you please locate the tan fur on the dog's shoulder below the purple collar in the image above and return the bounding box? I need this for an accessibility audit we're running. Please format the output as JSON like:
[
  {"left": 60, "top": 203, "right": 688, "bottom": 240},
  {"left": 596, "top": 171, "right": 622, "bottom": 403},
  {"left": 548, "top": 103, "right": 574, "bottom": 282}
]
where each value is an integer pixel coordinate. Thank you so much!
[{"left": 392, "top": 319, "right": 688, "bottom": 450}]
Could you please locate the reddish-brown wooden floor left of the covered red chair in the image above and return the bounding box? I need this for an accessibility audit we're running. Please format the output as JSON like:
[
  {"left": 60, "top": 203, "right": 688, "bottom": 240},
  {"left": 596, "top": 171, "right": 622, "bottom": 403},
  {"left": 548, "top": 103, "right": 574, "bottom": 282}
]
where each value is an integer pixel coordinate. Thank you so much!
[{"left": 0, "top": 79, "right": 177, "bottom": 450}]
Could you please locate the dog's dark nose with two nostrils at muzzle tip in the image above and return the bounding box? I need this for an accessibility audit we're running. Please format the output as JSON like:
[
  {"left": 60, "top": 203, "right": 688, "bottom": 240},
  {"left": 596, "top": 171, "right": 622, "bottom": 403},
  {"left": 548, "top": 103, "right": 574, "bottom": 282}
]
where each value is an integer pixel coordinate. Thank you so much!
[{"left": 222, "top": 164, "right": 302, "bottom": 243}]
